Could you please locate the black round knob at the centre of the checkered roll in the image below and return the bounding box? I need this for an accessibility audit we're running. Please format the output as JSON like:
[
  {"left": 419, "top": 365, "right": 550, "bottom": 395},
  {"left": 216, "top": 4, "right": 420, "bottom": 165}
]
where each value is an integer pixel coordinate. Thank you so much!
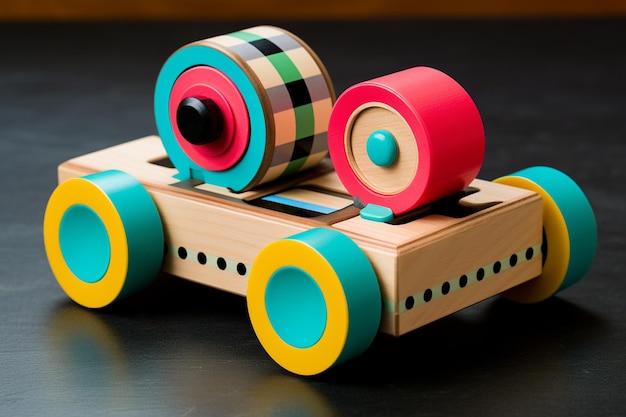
[{"left": 176, "top": 97, "right": 224, "bottom": 145}]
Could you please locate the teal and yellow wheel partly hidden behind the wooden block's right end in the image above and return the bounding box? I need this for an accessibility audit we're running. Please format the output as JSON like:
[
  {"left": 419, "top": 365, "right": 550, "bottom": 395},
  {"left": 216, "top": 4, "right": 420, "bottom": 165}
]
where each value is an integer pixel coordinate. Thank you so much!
[{"left": 495, "top": 167, "right": 598, "bottom": 303}]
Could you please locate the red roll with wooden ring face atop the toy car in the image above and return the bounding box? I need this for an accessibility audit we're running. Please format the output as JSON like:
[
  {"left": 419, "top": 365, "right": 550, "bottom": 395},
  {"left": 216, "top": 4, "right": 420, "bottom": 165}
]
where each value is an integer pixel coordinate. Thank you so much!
[{"left": 328, "top": 67, "right": 485, "bottom": 215}]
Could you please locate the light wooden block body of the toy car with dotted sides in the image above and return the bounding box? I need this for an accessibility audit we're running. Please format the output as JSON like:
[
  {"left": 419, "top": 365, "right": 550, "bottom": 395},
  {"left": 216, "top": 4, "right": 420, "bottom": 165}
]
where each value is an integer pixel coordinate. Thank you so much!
[{"left": 59, "top": 136, "right": 542, "bottom": 336}]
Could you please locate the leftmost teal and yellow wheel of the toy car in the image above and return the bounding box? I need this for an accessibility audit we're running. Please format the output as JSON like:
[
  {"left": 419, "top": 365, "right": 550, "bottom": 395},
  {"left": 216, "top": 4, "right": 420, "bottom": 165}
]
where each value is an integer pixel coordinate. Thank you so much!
[{"left": 43, "top": 171, "right": 164, "bottom": 308}]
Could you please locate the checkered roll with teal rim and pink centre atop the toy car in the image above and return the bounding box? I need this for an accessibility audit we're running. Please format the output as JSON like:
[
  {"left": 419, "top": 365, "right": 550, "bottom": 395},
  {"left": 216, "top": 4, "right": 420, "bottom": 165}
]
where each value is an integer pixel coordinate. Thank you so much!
[{"left": 154, "top": 26, "right": 335, "bottom": 191}]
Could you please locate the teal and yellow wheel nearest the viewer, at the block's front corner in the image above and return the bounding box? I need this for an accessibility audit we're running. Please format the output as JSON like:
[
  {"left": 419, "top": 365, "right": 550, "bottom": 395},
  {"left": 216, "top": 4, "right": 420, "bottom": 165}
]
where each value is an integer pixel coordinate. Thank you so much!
[{"left": 247, "top": 229, "right": 381, "bottom": 375}]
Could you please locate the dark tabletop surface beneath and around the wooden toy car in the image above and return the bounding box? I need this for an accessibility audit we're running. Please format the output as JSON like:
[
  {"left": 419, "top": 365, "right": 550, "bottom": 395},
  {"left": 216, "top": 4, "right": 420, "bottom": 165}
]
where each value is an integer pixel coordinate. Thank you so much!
[{"left": 0, "top": 20, "right": 626, "bottom": 416}]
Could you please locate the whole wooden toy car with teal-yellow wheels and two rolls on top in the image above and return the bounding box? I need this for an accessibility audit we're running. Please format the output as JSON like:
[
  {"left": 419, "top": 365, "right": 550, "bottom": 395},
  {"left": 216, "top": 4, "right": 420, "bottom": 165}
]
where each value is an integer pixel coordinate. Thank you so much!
[{"left": 44, "top": 26, "right": 596, "bottom": 375}]
